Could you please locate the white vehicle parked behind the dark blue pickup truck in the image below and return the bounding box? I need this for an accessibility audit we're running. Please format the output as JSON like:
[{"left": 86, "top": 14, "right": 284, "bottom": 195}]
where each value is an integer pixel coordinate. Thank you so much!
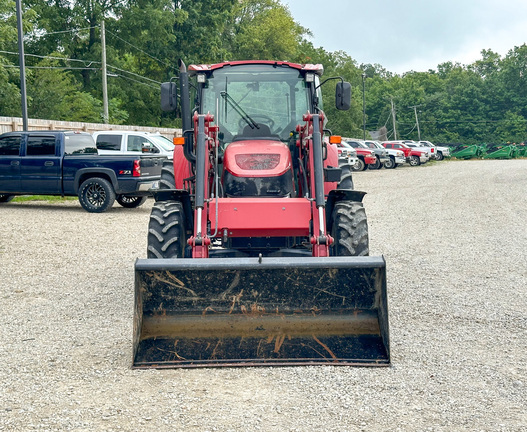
[{"left": 93, "top": 131, "right": 174, "bottom": 159}]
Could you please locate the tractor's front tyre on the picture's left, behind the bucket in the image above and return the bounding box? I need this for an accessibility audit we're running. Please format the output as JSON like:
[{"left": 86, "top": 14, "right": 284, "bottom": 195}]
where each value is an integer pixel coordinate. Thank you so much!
[{"left": 146, "top": 201, "right": 187, "bottom": 258}]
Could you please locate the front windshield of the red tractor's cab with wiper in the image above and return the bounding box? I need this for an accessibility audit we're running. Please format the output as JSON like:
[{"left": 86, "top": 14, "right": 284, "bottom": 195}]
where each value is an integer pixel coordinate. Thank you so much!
[{"left": 202, "top": 65, "right": 310, "bottom": 142}]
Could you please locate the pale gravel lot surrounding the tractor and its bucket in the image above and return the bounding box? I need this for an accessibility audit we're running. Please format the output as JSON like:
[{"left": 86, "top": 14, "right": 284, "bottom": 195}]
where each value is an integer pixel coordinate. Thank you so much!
[{"left": 0, "top": 159, "right": 527, "bottom": 431}]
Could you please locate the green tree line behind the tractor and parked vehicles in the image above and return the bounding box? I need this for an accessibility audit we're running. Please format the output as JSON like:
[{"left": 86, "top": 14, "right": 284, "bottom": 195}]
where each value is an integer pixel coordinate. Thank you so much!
[{"left": 0, "top": 0, "right": 527, "bottom": 144}]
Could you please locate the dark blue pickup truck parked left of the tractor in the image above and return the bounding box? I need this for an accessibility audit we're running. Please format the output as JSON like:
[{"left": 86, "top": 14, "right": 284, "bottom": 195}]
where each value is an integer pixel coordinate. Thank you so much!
[{"left": 0, "top": 131, "right": 166, "bottom": 213}]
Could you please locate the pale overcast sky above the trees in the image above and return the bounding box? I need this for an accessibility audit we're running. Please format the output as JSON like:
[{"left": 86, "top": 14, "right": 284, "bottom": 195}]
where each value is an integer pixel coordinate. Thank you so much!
[{"left": 281, "top": 0, "right": 527, "bottom": 73}]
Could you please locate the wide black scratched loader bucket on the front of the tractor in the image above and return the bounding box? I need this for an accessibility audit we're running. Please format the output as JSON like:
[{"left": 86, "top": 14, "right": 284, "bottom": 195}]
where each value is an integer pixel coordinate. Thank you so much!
[{"left": 133, "top": 257, "right": 390, "bottom": 368}]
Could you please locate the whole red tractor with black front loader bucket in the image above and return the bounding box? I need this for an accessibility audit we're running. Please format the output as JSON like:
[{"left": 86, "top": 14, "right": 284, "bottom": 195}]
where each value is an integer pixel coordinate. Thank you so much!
[{"left": 133, "top": 61, "right": 390, "bottom": 368}]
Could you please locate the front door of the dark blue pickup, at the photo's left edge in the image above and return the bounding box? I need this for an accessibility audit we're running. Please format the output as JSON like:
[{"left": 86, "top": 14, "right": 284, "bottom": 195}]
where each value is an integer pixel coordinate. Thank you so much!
[{"left": 0, "top": 134, "right": 22, "bottom": 193}]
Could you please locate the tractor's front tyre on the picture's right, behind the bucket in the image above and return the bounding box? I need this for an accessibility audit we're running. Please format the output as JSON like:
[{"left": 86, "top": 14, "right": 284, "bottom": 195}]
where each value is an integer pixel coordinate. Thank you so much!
[{"left": 331, "top": 201, "right": 370, "bottom": 256}]
